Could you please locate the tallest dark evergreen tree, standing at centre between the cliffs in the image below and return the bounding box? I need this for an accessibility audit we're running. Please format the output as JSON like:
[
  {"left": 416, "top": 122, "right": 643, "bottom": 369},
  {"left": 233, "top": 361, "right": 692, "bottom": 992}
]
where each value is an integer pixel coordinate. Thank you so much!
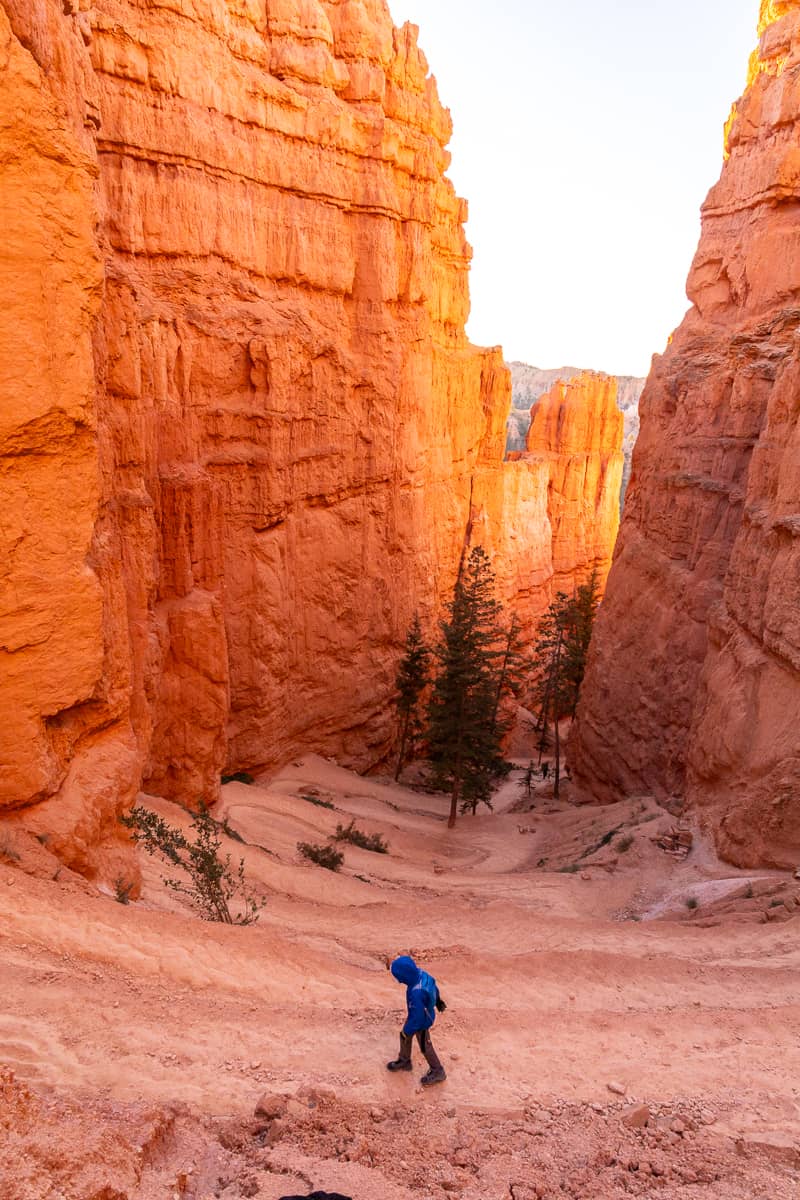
[{"left": 428, "top": 546, "right": 505, "bottom": 828}]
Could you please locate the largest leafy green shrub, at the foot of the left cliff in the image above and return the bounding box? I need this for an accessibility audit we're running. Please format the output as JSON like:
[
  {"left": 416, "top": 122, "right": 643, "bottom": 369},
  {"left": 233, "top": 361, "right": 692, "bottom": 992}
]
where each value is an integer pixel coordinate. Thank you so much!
[{"left": 120, "top": 805, "right": 265, "bottom": 925}]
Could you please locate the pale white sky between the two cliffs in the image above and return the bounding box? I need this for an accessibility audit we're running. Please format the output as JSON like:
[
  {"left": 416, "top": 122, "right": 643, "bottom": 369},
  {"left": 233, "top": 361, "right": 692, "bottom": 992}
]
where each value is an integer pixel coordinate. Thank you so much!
[{"left": 389, "top": 0, "right": 759, "bottom": 374}]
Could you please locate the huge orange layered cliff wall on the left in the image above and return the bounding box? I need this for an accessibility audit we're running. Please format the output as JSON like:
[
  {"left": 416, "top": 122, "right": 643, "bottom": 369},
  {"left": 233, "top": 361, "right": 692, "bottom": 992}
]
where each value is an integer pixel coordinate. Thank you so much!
[{"left": 0, "top": 0, "right": 623, "bottom": 871}]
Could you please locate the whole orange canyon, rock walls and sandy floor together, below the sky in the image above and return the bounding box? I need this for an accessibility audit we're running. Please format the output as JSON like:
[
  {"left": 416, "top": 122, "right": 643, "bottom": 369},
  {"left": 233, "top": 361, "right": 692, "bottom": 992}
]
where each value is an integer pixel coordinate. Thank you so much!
[{"left": 0, "top": 0, "right": 800, "bottom": 1200}]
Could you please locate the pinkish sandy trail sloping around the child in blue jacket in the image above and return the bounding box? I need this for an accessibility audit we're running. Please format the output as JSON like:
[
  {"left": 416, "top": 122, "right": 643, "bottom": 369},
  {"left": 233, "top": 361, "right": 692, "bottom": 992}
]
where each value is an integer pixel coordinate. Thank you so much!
[{"left": 0, "top": 757, "right": 800, "bottom": 1200}]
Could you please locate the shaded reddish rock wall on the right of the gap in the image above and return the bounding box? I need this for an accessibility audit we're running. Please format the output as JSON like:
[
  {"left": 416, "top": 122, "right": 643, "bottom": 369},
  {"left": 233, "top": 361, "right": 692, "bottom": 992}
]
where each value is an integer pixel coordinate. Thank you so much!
[{"left": 572, "top": 0, "right": 800, "bottom": 865}]
